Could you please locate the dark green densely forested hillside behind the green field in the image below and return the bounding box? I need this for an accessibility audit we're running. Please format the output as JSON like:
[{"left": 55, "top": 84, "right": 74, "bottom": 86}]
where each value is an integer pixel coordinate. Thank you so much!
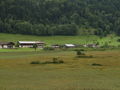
[{"left": 0, "top": 0, "right": 120, "bottom": 36}]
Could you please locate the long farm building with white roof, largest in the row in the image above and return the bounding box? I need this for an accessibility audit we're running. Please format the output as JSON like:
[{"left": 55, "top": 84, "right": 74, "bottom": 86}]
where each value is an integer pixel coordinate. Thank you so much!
[{"left": 18, "top": 41, "right": 45, "bottom": 48}]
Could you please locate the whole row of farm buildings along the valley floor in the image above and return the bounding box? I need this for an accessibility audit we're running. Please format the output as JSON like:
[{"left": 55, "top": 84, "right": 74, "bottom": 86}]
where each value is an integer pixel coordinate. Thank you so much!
[{"left": 0, "top": 41, "right": 98, "bottom": 48}]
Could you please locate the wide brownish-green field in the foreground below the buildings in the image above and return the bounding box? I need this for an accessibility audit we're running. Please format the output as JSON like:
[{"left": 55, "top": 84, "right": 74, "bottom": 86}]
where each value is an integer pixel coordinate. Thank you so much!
[{"left": 0, "top": 50, "right": 120, "bottom": 90}]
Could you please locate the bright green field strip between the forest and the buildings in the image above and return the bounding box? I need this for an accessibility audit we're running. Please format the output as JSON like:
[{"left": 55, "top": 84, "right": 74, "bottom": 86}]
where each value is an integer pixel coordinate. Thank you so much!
[{"left": 0, "top": 33, "right": 120, "bottom": 46}]
